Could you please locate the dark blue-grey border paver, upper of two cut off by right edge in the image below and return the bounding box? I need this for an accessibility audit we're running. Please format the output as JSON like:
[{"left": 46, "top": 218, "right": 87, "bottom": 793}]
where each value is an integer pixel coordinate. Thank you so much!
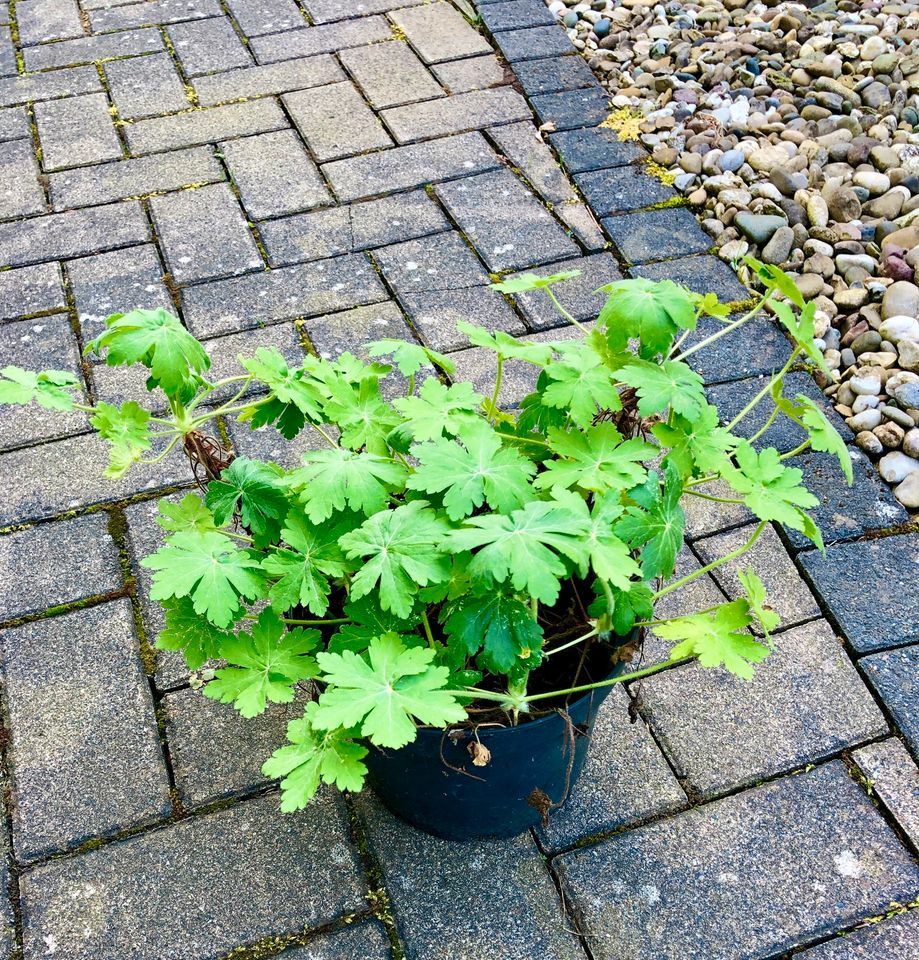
[{"left": 800, "top": 533, "right": 919, "bottom": 653}]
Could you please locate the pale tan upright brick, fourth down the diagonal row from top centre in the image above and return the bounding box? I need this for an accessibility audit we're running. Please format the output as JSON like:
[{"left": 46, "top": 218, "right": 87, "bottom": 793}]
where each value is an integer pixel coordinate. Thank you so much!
[{"left": 220, "top": 130, "right": 332, "bottom": 220}]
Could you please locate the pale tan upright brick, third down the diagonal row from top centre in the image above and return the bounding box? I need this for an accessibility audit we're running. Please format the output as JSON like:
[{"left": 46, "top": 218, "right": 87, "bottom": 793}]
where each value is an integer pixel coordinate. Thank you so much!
[{"left": 282, "top": 82, "right": 392, "bottom": 163}]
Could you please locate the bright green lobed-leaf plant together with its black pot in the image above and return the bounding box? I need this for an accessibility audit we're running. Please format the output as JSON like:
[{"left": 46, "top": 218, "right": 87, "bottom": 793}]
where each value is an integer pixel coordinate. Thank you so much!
[{"left": 0, "top": 261, "right": 851, "bottom": 837}]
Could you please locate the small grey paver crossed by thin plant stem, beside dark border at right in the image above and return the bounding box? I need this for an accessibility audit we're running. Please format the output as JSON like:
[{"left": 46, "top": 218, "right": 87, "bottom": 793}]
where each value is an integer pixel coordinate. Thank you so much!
[{"left": 693, "top": 526, "right": 820, "bottom": 632}]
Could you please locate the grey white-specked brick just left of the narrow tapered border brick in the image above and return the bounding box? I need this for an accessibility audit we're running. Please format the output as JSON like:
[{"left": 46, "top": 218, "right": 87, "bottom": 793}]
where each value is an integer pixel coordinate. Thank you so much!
[{"left": 435, "top": 170, "right": 578, "bottom": 271}]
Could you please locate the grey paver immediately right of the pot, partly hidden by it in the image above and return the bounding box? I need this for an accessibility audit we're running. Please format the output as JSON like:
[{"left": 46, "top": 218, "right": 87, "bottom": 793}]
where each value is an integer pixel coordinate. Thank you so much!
[{"left": 537, "top": 688, "right": 687, "bottom": 851}]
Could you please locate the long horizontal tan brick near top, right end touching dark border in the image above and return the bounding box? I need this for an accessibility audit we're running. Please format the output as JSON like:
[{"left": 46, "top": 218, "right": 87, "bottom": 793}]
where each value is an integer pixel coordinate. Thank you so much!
[{"left": 380, "top": 87, "right": 530, "bottom": 143}]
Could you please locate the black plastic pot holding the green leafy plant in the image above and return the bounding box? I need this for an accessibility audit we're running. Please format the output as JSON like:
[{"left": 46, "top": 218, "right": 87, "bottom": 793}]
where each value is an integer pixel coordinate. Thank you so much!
[{"left": 365, "top": 664, "right": 626, "bottom": 840}]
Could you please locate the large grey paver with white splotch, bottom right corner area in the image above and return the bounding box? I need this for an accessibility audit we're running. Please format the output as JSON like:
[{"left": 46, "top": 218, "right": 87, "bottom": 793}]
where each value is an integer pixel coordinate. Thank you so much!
[{"left": 556, "top": 763, "right": 919, "bottom": 960}]
